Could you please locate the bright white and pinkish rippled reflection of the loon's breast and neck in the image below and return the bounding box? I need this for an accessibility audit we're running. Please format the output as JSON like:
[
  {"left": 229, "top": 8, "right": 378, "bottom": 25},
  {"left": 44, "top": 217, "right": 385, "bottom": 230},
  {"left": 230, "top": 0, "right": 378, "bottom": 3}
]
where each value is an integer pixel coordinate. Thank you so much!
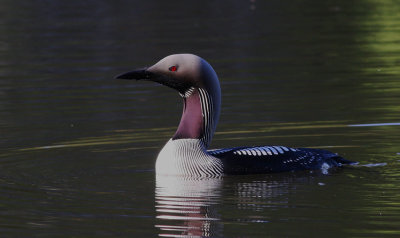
[{"left": 155, "top": 175, "right": 223, "bottom": 237}]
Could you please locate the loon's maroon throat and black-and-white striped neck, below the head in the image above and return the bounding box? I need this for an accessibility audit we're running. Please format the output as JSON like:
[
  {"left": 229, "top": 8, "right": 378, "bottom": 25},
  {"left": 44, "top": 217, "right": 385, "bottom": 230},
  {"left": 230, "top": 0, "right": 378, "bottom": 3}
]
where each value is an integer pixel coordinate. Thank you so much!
[{"left": 172, "top": 88, "right": 219, "bottom": 148}]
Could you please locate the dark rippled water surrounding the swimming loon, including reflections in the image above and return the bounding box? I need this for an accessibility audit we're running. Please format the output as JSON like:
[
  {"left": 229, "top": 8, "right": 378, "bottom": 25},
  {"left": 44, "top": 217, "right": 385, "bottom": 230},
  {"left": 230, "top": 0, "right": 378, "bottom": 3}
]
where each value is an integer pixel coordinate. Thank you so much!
[{"left": 0, "top": 0, "right": 400, "bottom": 237}]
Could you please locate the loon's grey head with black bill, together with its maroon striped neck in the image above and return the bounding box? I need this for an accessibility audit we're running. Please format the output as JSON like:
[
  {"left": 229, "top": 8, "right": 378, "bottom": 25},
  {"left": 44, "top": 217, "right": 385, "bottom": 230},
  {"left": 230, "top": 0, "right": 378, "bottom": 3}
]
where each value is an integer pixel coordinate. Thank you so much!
[{"left": 116, "top": 54, "right": 221, "bottom": 147}]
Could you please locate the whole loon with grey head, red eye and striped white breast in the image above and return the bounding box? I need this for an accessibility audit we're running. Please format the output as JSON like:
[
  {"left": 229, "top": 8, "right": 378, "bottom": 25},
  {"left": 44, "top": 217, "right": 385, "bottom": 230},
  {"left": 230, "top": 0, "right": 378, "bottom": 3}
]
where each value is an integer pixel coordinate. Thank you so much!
[{"left": 116, "top": 54, "right": 353, "bottom": 177}]
